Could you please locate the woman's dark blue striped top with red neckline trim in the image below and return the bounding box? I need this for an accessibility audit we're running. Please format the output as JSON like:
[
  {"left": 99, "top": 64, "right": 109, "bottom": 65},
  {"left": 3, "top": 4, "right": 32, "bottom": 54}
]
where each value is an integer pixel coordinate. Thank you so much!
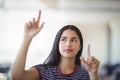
[{"left": 34, "top": 65, "right": 90, "bottom": 80}]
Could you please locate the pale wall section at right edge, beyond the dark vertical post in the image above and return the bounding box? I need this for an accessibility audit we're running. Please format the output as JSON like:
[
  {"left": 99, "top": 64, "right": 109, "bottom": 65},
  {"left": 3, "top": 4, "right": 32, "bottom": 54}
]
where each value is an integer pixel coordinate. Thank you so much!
[{"left": 110, "top": 19, "right": 120, "bottom": 64}]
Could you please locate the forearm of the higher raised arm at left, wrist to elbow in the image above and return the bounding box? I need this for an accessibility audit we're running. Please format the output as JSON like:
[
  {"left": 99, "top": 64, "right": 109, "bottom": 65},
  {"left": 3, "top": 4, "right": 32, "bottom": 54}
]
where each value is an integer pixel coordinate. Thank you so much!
[{"left": 12, "top": 38, "right": 32, "bottom": 79}]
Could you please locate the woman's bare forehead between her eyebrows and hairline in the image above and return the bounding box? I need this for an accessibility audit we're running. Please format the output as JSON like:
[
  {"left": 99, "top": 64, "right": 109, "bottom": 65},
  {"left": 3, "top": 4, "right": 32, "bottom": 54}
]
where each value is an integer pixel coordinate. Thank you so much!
[{"left": 61, "top": 29, "right": 78, "bottom": 38}]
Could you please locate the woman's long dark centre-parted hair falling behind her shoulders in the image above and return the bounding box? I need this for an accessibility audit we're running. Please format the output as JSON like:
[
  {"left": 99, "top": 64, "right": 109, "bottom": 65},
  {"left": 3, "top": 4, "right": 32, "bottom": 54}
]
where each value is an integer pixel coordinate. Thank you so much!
[{"left": 43, "top": 25, "right": 83, "bottom": 66}]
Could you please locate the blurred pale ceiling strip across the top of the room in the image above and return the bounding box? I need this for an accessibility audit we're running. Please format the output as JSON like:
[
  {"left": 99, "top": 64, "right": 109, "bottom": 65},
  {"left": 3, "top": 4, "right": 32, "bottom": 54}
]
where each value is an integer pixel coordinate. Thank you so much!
[{"left": 0, "top": 0, "right": 120, "bottom": 12}]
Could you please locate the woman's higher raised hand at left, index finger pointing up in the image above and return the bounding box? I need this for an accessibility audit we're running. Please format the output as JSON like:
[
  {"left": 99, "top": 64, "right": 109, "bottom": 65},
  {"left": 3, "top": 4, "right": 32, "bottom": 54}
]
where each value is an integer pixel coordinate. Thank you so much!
[{"left": 24, "top": 10, "right": 44, "bottom": 38}]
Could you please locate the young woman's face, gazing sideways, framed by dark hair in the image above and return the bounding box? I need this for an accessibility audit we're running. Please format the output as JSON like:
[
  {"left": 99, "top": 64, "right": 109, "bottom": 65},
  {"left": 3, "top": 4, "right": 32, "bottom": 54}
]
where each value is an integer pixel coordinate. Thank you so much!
[{"left": 59, "top": 29, "right": 81, "bottom": 58}]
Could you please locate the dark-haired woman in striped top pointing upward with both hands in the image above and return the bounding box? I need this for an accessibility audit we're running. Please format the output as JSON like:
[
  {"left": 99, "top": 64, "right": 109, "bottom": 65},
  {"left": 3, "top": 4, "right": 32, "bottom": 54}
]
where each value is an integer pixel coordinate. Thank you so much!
[{"left": 12, "top": 11, "right": 99, "bottom": 80}]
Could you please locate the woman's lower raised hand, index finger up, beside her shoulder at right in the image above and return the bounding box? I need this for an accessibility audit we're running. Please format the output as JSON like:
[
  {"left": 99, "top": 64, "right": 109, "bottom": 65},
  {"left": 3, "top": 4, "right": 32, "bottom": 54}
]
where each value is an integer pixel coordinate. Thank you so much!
[{"left": 80, "top": 44, "right": 100, "bottom": 74}]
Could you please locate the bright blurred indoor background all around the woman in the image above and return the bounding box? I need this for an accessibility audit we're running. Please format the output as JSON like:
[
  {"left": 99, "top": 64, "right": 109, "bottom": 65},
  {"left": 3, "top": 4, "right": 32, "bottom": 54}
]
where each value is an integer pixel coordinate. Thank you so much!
[{"left": 0, "top": 0, "right": 120, "bottom": 80}]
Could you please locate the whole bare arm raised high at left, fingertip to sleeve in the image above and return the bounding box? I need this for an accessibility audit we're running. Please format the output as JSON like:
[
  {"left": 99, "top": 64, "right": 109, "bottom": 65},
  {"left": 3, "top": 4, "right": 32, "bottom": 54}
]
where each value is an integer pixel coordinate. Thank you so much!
[{"left": 12, "top": 11, "right": 44, "bottom": 80}]
